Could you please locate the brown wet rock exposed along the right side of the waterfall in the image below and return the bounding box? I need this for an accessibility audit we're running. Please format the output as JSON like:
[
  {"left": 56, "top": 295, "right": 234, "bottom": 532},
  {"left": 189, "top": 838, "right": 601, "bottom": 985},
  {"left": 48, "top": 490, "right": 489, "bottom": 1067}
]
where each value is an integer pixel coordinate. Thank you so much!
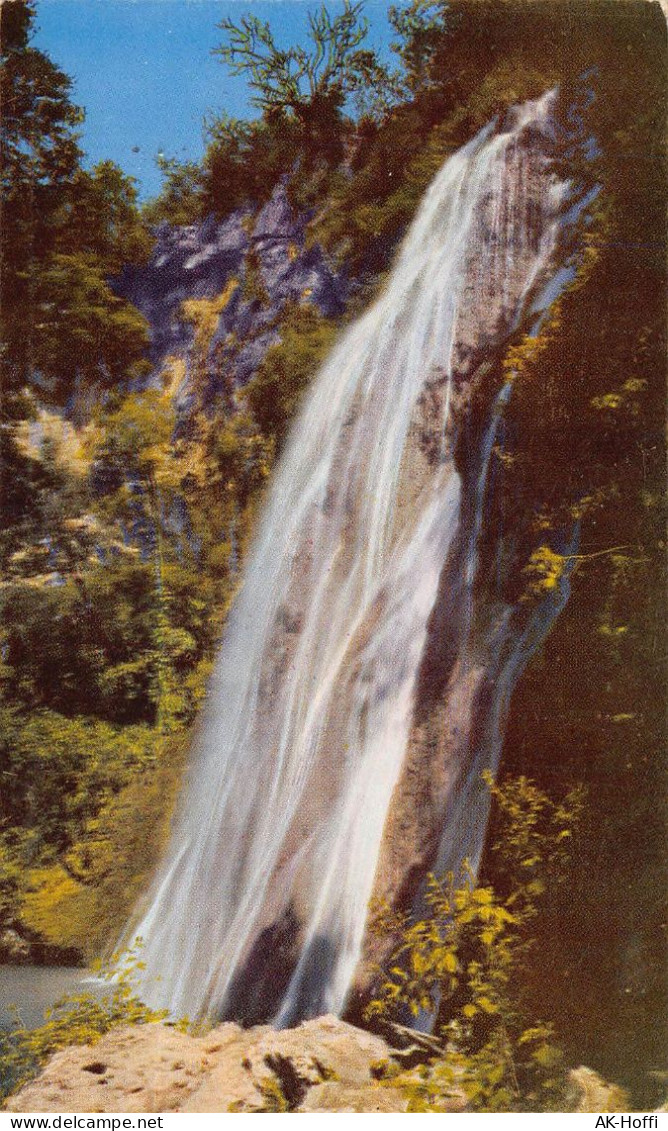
[{"left": 345, "top": 99, "right": 587, "bottom": 1020}]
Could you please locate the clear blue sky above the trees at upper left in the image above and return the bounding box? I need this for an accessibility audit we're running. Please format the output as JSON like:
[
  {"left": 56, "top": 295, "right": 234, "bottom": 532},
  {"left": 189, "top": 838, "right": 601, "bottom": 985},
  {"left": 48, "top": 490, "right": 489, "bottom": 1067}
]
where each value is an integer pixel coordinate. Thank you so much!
[{"left": 33, "top": 0, "right": 402, "bottom": 198}]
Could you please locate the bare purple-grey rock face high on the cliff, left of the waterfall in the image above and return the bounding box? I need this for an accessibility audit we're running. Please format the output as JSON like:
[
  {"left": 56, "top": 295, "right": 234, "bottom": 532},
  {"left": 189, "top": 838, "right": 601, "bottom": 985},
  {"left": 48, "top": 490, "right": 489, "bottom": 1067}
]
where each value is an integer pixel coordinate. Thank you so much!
[{"left": 115, "top": 182, "right": 346, "bottom": 399}]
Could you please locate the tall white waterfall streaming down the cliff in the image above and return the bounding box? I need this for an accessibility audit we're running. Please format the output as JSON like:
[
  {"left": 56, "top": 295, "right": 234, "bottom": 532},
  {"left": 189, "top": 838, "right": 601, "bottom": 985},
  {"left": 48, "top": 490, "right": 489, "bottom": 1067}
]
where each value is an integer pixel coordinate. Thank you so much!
[{"left": 125, "top": 92, "right": 587, "bottom": 1026}]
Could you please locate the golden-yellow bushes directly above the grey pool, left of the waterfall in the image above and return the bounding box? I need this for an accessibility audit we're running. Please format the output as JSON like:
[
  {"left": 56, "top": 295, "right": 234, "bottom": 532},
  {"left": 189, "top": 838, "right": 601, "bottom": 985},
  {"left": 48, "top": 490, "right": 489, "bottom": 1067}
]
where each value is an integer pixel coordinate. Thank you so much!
[{"left": 5, "top": 720, "right": 189, "bottom": 962}]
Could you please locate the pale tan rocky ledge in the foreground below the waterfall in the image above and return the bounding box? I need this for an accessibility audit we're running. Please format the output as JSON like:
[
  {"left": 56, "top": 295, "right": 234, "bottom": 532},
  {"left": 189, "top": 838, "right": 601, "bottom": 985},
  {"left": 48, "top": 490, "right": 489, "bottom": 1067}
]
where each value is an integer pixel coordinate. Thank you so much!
[{"left": 6, "top": 1017, "right": 626, "bottom": 1113}]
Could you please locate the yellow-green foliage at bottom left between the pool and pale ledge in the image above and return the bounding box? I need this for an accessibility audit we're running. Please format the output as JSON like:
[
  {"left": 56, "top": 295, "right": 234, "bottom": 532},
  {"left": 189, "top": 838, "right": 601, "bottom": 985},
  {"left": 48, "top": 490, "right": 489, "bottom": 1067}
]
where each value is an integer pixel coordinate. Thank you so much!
[{"left": 0, "top": 955, "right": 166, "bottom": 1098}]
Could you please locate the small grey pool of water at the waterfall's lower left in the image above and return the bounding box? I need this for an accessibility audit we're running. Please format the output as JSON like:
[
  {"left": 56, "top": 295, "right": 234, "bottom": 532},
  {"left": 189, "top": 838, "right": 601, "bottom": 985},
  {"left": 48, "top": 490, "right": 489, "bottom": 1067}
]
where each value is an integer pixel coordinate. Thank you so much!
[{"left": 0, "top": 965, "right": 103, "bottom": 1028}]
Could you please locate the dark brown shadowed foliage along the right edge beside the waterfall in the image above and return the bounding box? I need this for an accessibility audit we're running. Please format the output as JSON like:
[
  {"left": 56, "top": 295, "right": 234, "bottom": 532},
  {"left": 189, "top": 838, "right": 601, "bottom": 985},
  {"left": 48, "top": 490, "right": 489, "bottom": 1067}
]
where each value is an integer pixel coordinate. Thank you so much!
[{"left": 474, "top": 30, "right": 666, "bottom": 1090}]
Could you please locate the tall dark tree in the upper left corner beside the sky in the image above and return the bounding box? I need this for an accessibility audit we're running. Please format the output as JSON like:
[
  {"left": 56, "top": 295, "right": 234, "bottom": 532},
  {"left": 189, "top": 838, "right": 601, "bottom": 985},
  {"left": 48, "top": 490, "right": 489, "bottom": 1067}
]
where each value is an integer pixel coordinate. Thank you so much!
[{"left": 0, "top": 0, "right": 148, "bottom": 407}]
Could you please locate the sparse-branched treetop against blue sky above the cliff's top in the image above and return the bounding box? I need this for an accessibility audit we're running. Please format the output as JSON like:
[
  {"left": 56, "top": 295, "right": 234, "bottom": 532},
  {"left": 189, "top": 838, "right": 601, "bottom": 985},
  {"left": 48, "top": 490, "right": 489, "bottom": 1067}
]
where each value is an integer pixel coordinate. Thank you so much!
[{"left": 175, "top": 0, "right": 393, "bottom": 222}]
